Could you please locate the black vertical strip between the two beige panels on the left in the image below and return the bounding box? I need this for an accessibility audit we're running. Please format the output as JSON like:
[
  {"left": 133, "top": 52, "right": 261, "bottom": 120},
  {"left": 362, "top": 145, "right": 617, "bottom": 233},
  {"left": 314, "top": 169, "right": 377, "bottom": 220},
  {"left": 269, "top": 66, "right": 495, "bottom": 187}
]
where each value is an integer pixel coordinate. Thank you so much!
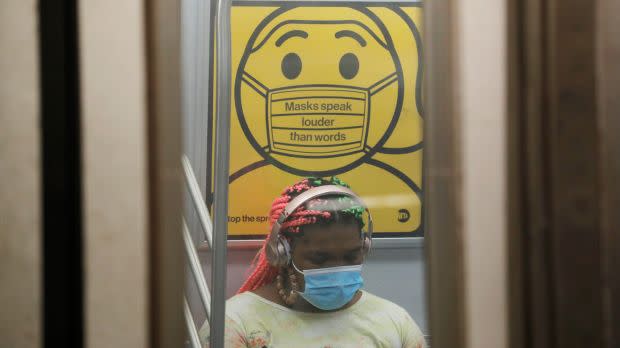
[{"left": 38, "top": 0, "right": 84, "bottom": 348}]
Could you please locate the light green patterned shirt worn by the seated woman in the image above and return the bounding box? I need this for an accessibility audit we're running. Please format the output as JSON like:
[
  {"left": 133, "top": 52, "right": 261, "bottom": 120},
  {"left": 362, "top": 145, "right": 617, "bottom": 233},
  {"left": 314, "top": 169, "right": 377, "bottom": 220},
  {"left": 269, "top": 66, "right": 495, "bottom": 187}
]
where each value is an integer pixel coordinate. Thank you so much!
[{"left": 200, "top": 291, "right": 426, "bottom": 348}]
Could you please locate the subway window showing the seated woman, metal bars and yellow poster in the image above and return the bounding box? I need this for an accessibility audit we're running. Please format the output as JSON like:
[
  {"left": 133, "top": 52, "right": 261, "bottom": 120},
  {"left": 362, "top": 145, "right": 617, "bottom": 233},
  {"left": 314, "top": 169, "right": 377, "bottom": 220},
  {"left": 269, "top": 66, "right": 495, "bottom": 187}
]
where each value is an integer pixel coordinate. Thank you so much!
[{"left": 181, "top": 0, "right": 430, "bottom": 347}]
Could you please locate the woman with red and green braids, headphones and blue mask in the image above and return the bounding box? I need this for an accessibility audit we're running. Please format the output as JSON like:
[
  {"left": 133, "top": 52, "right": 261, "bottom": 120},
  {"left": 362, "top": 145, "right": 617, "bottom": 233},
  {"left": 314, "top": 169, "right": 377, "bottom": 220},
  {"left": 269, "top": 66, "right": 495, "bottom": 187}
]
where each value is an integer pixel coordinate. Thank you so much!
[{"left": 201, "top": 178, "right": 425, "bottom": 348}]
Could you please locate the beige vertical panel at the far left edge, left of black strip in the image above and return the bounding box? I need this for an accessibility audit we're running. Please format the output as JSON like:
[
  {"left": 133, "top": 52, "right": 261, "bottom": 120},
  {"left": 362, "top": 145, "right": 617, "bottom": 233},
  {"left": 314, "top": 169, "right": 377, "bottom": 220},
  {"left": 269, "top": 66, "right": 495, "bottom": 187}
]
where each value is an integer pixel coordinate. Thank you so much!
[{"left": 0, "top": 0, "right": 42, "bottom": 347}]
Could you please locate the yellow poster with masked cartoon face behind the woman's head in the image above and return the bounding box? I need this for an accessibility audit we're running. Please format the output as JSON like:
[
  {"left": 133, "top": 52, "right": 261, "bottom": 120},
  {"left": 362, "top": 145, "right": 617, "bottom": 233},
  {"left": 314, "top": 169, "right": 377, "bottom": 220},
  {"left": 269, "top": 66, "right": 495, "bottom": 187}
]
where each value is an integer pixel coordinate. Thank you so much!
[{"left": 208, "top": 2, "right": 423, "bottom": 239}]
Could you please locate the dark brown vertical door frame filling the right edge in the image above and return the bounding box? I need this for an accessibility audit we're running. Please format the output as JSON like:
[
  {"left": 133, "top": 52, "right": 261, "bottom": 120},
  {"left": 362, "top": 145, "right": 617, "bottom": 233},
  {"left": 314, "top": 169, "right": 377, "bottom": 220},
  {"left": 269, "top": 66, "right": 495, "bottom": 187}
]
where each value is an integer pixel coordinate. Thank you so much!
[{"left": 508, "top": 0, "right": 620, "bottom": 348}]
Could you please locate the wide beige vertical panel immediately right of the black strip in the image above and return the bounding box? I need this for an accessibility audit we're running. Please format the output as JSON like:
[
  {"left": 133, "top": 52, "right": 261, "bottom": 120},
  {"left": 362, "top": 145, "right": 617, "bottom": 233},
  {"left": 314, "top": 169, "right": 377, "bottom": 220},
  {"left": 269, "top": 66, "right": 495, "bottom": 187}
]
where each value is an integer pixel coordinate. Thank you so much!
[{"left": 78, "top": 0, "right": 148, "bottom": 348}]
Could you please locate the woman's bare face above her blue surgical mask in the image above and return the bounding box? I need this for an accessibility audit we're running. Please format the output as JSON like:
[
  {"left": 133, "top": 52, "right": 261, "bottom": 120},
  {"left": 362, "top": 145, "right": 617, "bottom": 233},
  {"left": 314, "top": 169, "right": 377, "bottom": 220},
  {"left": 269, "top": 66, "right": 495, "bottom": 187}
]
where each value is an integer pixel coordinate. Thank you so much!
[{"left": 292, "top": 223, "right": 363, "bottom": 290}]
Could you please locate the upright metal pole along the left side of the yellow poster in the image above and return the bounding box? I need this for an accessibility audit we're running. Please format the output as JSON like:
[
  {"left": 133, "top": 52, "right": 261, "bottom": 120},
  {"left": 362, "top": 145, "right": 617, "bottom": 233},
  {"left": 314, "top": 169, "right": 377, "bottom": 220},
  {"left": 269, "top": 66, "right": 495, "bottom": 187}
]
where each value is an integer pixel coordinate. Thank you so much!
[{"left": 209, "top": 0, "right": 231, "bottom": 348}]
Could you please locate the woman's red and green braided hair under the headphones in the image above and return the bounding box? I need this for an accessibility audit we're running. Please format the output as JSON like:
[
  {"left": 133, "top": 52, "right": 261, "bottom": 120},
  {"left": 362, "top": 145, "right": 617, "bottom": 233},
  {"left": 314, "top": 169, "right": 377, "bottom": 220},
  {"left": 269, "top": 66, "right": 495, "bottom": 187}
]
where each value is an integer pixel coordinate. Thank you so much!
[{"left": 237, "top": 177, "right": 365, "bottom": 294}]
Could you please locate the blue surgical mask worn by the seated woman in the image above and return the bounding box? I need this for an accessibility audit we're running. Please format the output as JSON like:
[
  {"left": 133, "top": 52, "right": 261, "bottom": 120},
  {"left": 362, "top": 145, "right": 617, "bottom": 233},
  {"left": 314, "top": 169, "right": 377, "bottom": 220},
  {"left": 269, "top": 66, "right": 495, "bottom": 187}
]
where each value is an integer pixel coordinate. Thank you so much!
[{"left": 293, "top": 263, "right": 364, "bottom": 311}]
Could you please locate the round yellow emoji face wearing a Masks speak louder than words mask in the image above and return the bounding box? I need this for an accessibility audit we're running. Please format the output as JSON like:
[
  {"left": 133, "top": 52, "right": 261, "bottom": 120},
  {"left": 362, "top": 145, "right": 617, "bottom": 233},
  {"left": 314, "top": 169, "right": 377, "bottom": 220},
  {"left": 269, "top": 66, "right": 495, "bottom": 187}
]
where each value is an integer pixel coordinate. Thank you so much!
[{"left": 235, "top": 7, "right": 403, "bottom": 175}]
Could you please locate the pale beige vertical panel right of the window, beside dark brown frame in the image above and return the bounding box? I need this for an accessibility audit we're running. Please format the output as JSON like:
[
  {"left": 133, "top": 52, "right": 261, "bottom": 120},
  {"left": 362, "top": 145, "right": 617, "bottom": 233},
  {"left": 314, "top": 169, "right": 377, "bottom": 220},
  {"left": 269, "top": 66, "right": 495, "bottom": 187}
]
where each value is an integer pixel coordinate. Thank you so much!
[{"left": 456, "top": 0, "right": 508, "bottom": 348}]
